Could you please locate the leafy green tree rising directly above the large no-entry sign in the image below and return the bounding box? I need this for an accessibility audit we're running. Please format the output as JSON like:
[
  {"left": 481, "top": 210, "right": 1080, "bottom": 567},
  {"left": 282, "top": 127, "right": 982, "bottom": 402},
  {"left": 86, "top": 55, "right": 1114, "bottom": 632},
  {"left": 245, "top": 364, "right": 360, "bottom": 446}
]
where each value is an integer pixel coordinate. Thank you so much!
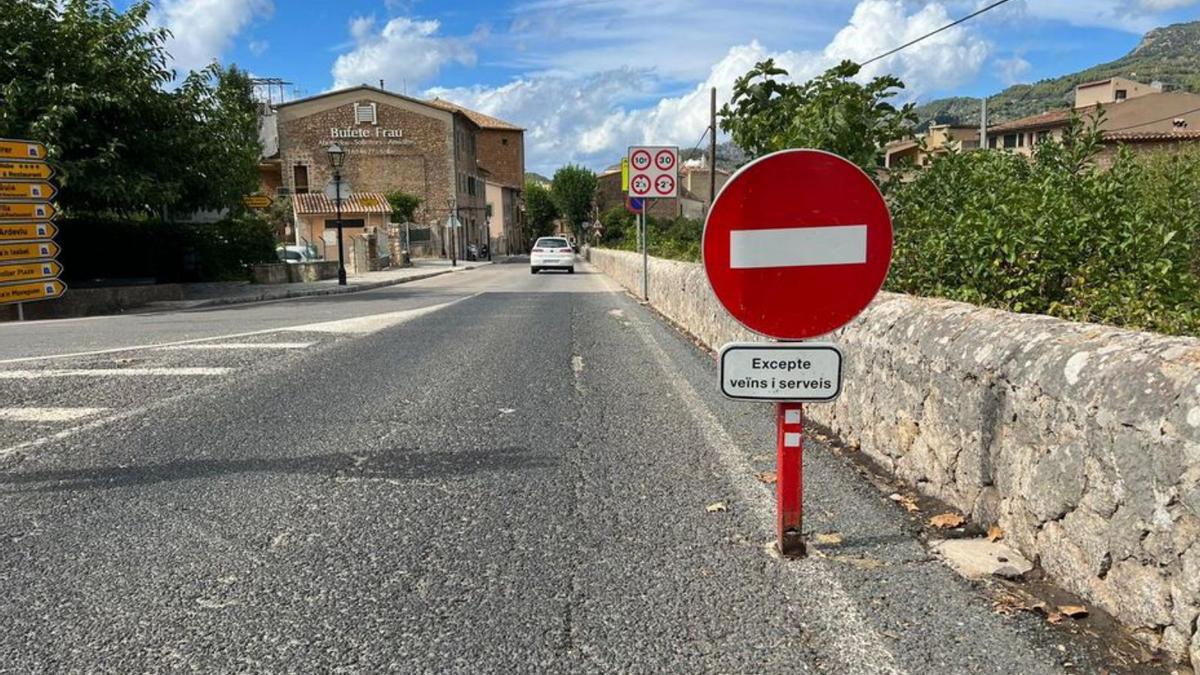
[{"left": 720, "top": 59, "right": 917, "bottom": 173}]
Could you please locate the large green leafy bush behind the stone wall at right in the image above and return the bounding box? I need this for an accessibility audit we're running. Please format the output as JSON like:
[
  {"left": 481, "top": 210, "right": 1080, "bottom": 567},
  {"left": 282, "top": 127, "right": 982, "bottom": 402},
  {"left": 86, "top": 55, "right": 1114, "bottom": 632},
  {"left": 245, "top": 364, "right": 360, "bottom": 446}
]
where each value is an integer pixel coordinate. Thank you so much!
[{"left": 888, "top": 120, "right": 1200, "bottom": 334}]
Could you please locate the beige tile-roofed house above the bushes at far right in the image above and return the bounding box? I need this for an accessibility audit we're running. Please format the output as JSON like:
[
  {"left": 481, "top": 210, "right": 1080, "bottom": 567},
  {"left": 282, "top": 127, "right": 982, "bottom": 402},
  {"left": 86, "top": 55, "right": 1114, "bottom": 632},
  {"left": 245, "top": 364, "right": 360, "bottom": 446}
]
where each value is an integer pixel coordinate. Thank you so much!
[{"left": 988, "top": 78, "right": 1200, "bottom": 155}]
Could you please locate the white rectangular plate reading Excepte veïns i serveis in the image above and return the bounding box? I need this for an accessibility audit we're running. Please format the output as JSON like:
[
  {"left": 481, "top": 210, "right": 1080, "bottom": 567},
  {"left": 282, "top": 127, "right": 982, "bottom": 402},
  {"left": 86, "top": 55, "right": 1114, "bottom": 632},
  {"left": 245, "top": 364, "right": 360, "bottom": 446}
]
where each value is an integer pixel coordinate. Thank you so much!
[{"left": 721, "top": 342, "right": 842, "bottom": 404}]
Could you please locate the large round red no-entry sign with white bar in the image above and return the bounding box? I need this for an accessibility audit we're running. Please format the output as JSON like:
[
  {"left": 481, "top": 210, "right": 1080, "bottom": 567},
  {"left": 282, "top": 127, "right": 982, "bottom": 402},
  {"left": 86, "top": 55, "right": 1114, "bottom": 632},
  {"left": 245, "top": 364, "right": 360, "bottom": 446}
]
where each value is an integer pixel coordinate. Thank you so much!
[{"left": 702, "top": 150, "right": 892, "bottom": 340}]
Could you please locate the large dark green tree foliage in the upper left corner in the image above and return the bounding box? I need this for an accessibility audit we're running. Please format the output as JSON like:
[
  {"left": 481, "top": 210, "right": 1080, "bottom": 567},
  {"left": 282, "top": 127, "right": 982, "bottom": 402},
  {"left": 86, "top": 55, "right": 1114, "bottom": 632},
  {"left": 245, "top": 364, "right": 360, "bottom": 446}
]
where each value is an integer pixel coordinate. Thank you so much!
[{"left": 0, "top": 0, "right": 260, "bottom": 214}]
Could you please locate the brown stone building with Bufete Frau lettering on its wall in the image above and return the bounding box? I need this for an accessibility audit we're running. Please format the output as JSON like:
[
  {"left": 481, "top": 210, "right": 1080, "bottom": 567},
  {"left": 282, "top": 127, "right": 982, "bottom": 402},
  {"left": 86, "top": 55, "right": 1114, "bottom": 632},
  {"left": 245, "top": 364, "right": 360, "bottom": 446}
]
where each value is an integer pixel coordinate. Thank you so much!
[{"left": 262, "top": 85, "right": 513, "bottom": 258}]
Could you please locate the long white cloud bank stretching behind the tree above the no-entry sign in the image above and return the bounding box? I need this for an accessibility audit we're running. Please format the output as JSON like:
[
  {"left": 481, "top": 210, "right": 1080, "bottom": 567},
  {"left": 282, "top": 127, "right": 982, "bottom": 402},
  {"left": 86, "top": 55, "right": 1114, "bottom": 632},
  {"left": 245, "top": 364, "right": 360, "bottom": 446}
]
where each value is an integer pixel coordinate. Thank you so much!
[{"left": 430, "top": 0, "right": 990, "bottom": 173}]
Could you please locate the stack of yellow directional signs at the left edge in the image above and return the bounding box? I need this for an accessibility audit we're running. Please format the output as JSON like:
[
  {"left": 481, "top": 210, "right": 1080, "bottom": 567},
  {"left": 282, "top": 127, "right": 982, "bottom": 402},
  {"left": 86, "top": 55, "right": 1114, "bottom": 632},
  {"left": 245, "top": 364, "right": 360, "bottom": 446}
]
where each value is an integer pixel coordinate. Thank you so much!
[{"left": 0, "top": 138, "right": 67, "bottom": 305}]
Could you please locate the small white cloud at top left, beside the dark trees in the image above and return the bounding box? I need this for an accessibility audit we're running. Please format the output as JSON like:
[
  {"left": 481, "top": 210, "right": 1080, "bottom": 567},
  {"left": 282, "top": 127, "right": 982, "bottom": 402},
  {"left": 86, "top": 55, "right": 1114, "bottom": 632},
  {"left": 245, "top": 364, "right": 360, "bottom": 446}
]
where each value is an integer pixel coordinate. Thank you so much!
[{"left": 150, "top": 0, "right": 275, "bottom": 74}]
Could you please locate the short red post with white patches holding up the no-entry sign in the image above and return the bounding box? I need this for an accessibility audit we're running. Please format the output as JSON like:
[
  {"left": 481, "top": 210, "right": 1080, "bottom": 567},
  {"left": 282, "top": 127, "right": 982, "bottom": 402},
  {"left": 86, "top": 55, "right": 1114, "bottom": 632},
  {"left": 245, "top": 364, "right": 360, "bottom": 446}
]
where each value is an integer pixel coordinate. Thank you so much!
[{"left": 775, "top": 402, "right": 805, "bottom": 557}]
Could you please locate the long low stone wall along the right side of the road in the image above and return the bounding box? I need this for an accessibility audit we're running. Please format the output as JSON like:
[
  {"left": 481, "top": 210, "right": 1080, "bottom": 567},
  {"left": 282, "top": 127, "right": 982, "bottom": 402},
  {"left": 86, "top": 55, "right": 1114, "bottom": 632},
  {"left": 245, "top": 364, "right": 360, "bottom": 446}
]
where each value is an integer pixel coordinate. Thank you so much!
[{"left": 589, "top": 250, "right": 1200, "bottom": 664}]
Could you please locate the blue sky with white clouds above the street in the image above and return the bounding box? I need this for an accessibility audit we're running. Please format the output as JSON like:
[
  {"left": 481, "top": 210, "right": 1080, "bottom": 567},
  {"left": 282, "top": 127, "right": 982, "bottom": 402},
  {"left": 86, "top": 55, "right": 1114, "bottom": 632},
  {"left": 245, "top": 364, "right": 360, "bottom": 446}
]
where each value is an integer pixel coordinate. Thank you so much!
[{"left": 129, "top": 0, "right": 1200, "bottom": 175}]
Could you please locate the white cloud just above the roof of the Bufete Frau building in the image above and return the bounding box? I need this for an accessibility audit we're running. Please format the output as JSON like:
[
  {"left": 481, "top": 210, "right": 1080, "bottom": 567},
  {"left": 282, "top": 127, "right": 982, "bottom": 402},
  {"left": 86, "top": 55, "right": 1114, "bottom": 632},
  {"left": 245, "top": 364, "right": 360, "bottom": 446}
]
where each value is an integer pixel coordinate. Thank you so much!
[{"left": 332, "top": 17, "right": 484, "bottom": 89}]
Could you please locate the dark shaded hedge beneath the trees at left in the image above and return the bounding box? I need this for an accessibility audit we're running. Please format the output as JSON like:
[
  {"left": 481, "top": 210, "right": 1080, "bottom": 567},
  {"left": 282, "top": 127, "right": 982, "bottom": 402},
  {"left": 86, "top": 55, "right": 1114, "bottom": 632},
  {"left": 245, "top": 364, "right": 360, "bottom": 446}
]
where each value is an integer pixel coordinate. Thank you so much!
[{"left": 58, "top": 212, "right": 277, "bottom": 283}]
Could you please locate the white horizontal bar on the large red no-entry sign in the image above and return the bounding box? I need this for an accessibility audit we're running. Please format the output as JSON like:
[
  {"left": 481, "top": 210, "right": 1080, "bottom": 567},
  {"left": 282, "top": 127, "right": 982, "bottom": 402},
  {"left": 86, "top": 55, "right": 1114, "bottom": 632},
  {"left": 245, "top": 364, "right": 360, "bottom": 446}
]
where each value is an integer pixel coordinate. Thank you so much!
[{"left": 730, "top": 225, "right": 866, "bottom": 269}]
